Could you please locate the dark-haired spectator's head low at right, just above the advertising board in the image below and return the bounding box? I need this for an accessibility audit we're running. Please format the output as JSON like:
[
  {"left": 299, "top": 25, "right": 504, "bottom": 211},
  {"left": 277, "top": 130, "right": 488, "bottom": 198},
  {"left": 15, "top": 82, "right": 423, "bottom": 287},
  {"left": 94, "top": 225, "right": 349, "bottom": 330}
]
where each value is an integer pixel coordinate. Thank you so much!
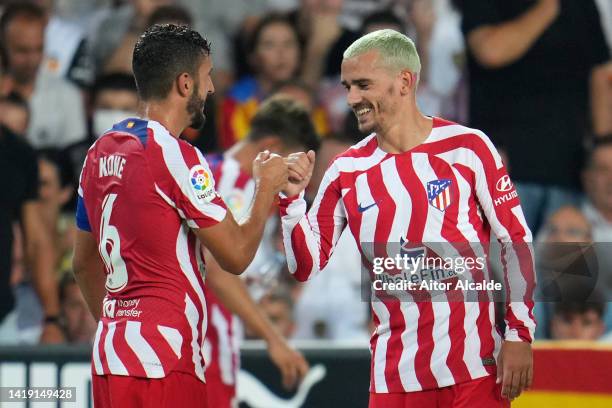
[{"left": 550, "top": 302, "right": 606, "bottom": 340}]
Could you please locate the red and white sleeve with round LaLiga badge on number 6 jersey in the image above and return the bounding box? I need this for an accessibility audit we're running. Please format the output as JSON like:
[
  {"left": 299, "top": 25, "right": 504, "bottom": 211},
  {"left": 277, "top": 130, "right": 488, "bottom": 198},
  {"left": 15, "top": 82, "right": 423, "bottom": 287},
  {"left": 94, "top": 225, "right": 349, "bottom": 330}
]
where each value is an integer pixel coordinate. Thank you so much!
[{"left": 150, "top": 138, "right": 227, "bottom": 228}]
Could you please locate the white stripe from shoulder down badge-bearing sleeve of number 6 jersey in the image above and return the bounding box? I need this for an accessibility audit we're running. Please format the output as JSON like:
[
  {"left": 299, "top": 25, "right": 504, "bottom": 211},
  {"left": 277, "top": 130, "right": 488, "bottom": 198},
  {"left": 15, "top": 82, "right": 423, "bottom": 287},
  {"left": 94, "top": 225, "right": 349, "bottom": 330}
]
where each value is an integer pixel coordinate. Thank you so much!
[{"left": 148, "top": 121, "right": 226, "bottom": 222}]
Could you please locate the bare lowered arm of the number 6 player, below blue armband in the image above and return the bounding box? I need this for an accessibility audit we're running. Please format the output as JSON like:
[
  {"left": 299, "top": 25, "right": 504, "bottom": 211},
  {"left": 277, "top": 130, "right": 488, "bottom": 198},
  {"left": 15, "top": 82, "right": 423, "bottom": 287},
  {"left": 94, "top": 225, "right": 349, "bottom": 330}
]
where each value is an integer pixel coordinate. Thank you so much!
[{"left": 72, "top": 230, "right": 106, "bottom": 321}]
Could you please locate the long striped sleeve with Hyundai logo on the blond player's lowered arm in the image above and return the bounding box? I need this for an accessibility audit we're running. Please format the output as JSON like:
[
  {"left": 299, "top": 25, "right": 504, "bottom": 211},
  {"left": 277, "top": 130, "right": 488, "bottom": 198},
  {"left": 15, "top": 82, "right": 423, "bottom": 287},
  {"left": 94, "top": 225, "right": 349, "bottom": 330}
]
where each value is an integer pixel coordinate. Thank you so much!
[{"left": 474, "top": 132, "right": 536, "bottom": 342}]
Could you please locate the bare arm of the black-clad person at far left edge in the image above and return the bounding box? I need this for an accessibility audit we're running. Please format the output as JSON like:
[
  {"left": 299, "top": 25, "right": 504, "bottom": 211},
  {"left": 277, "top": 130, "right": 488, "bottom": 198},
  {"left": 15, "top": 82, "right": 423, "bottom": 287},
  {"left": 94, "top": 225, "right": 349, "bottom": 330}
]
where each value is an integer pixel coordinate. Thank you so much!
[{"left": 22, "top": 201, "right": 64, "bottom": 343}]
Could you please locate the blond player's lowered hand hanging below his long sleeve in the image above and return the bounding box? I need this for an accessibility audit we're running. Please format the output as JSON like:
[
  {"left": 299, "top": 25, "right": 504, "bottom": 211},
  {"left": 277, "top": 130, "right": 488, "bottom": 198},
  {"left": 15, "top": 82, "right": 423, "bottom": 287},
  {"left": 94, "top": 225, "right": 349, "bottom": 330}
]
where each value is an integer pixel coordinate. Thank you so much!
[{"left": 497, "top": 341, "right": 533, "bottom": 401}]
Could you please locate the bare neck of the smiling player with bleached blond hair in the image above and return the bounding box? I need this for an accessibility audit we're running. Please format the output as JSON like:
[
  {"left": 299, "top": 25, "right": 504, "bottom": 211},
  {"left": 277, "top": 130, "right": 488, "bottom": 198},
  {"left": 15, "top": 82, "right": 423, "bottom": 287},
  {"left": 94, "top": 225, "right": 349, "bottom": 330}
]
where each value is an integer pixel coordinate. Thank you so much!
[{"left": 376, "top": 104, "right": 433, "bottom": 153}]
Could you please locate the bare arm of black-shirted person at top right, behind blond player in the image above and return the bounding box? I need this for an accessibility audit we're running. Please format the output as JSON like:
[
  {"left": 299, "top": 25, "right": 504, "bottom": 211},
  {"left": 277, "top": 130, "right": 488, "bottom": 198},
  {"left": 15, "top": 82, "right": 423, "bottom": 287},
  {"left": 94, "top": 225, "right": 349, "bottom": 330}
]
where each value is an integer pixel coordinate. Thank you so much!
[{"left": 467, "top": 0, "right": 560, "bottom": 68}]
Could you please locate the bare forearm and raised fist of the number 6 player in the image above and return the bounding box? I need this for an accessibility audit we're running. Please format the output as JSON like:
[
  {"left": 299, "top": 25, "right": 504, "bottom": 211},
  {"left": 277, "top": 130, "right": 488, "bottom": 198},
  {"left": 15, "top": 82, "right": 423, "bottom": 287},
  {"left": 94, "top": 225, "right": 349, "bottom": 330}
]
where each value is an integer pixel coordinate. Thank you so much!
[{"left": 195, "top": 152, "right": 288, "bottom": 275}]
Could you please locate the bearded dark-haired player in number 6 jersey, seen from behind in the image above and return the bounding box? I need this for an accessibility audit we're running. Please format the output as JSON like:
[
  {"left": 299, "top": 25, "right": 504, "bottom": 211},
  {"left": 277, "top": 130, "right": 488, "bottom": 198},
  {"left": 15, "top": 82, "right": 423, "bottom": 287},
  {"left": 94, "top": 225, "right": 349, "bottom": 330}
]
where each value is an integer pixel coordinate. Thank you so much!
[{"left": 73, "top": 24, "right": 288, "bottom": 408}]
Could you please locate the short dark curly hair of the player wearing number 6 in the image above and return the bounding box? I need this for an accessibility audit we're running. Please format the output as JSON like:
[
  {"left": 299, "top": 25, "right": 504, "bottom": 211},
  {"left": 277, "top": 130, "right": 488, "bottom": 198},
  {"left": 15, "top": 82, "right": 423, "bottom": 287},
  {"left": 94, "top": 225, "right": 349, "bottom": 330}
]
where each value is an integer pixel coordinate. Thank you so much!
[{"left": 132, "top": 24, "right": 210, "bottom": 101}]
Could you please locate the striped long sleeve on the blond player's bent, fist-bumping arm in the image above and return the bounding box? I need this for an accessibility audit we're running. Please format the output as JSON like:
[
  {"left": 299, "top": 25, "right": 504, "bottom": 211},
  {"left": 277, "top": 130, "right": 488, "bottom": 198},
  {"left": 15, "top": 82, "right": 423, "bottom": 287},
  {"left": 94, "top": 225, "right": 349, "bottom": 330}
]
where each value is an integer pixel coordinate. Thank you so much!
[{"left": 280, "top": 159, "right": 346, "bottom": 282}]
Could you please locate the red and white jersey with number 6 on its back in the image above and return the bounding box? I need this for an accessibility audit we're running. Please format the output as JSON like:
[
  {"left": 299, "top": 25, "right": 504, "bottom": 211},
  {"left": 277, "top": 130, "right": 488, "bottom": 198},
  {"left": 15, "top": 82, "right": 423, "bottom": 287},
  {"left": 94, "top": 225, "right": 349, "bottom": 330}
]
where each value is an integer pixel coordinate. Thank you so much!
[{"left": 77, "top": 119, "right": 227, "bottom": 381}]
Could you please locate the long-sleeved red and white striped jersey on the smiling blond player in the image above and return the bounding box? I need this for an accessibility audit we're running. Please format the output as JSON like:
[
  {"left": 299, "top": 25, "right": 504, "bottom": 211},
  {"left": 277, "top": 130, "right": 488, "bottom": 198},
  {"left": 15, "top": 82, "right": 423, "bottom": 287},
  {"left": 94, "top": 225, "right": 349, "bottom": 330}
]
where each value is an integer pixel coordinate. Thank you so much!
[{"left": 281, "top": 118, "right": 535, "bottom": 393}]
